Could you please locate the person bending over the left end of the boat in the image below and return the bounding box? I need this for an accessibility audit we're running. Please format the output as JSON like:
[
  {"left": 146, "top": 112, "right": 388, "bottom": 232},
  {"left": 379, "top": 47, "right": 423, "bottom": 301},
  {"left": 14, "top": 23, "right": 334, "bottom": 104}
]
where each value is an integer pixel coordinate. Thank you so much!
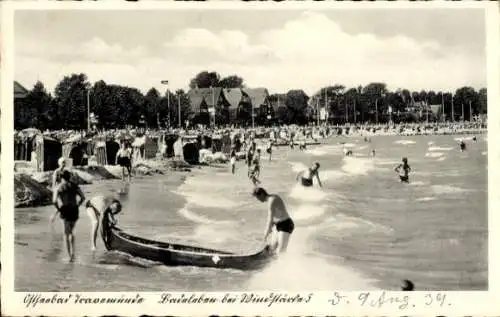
[{"left": 85, "top": 195, "right": 122, "bottom": 251}]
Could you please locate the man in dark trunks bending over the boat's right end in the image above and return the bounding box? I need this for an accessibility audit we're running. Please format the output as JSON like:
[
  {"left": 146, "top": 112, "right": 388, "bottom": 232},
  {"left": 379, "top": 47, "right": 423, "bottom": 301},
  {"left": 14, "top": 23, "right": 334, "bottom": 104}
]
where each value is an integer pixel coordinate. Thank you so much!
[{"left": 252, "top": 187, "right": 295, "bottom": 253}]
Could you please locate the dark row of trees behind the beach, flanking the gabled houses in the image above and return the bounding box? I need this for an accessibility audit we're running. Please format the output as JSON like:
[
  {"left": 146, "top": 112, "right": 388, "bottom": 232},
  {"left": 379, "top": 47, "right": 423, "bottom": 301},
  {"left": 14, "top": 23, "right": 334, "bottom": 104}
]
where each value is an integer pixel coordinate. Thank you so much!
[{"left": 14, "top": 71, "right": 487, "bottom": 130}]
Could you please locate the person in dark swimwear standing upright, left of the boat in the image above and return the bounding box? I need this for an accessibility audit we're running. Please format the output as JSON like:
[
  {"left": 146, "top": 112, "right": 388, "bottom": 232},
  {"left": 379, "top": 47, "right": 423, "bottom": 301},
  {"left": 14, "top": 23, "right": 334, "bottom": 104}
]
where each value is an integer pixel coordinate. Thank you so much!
[{"left": 51, "top": 171, "right": 85, "bottom": 262}]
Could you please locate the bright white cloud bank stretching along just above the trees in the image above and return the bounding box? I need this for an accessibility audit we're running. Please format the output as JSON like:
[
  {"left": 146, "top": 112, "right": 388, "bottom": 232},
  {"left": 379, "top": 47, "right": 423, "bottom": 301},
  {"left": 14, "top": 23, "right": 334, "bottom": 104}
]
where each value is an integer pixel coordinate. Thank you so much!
[{"left": 16, "top": 12, "right": 486, "bottom": 93}]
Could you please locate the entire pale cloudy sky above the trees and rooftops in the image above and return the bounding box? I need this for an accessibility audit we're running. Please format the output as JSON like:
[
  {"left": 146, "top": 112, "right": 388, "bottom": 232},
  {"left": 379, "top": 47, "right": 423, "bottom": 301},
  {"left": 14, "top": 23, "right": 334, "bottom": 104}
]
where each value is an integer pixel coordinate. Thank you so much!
[{"left": 14, "top": 8, "right": 486, "bottom": 94}]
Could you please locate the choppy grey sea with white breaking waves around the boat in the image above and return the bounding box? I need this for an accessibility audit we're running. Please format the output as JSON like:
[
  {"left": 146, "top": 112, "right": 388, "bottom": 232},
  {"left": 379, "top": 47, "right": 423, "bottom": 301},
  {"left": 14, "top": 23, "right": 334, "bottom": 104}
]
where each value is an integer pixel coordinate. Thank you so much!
[{"left": 14, "top": 135, "right": 488, "bottom": 291}]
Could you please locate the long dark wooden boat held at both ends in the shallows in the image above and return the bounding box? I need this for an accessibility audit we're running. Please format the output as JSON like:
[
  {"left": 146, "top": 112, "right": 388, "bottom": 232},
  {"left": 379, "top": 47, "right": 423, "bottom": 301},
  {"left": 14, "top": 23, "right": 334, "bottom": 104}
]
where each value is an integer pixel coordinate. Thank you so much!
[{"left": 101, "top": 214, "right": 274, "bottom": 270}]
